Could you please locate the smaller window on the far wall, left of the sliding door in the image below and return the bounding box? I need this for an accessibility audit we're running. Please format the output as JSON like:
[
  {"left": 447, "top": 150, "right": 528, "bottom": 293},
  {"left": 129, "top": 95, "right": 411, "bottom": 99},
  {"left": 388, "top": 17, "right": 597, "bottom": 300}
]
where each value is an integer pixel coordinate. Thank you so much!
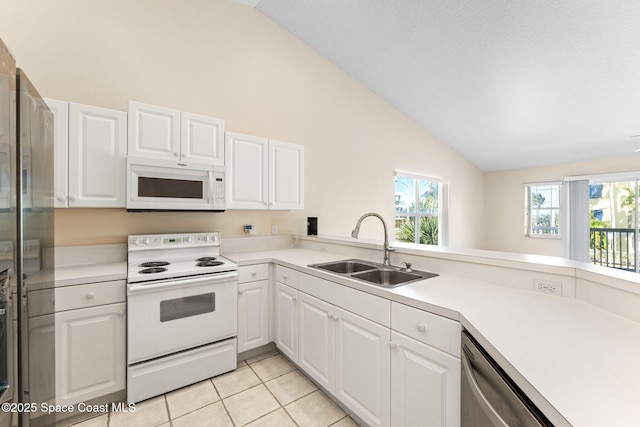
[{"left": 525, "top": 182, "right": 561, "bottom": 238}]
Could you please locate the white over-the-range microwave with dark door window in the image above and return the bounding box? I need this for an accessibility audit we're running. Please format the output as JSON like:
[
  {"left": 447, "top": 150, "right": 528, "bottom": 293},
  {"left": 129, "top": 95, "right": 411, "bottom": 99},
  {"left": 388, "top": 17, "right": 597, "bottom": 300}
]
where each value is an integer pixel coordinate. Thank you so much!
[{"left": 127, "top": 157, "right": 226, "bottom": 212}]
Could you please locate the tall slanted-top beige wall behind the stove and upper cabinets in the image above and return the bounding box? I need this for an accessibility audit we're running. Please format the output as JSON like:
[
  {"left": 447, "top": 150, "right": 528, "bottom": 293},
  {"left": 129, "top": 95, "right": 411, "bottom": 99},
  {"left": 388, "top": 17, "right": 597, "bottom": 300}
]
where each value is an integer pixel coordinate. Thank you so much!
[{"left": 0, "top": 0, "right": 485, "bottom": 247}]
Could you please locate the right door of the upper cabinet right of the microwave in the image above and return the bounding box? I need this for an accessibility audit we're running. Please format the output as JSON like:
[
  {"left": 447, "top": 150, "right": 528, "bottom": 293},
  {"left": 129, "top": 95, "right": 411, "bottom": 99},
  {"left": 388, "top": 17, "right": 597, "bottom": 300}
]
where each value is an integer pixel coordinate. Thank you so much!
[{"left": 269, "top": 140, "right": 304, "bottom": 209}]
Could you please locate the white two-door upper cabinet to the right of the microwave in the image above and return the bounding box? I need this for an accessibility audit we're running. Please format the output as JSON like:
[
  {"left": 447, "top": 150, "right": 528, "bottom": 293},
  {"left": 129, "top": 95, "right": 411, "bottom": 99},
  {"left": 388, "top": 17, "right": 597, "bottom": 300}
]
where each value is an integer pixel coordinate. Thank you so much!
[{"left": 225, "top": 132, "right": 304, "bottom": 210}]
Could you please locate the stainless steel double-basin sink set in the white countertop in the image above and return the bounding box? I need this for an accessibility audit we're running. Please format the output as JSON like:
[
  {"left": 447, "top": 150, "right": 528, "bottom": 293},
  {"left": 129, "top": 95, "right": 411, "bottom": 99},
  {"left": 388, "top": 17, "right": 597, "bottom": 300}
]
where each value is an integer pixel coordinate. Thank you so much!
[{"left": 309, "top": 259, "right": 437, "bottom": 288}]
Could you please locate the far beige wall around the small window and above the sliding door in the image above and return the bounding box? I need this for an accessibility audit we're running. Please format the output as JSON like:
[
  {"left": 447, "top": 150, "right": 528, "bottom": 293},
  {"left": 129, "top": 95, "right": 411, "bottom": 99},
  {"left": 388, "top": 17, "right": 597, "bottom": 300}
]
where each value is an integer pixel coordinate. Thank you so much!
[{"left": 486, "top": 155, "right": 640, "bottom": 257}]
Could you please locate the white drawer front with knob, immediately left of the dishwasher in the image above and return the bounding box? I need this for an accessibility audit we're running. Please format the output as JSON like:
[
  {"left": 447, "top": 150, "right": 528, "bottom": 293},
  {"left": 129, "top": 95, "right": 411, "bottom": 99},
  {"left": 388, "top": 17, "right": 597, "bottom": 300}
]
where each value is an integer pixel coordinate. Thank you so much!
[{"left": 391, "top": 302, "right": 461, "bottom": 357}]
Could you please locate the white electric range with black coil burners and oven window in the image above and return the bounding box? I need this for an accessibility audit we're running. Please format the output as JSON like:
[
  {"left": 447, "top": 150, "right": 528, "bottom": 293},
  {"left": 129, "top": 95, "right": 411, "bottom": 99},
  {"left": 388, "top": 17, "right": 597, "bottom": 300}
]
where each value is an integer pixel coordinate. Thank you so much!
[{"left": 127, "top": 232, "right": 238, "bottom": 403}]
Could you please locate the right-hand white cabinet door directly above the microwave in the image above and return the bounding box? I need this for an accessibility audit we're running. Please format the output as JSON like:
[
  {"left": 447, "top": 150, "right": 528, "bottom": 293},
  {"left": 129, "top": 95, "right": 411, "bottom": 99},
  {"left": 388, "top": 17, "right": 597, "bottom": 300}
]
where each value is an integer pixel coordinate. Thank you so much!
[{"left": 180, "top": 113, "right": 224, "bottom": 165}]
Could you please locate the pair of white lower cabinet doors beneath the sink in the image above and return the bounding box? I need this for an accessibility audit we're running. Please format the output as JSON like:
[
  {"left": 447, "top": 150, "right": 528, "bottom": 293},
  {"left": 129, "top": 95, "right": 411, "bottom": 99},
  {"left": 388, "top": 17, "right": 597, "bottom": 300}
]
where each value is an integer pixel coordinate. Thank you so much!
[{"left": 298, "top": 292, "right": 391, "bottom": 426}]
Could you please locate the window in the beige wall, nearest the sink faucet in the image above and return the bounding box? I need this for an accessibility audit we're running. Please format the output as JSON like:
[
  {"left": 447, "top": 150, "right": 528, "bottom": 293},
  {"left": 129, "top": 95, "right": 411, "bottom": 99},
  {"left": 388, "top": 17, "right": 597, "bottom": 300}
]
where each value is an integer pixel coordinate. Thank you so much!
[{"left": 395, "top": 172, "right": 447, "bottom": 245}]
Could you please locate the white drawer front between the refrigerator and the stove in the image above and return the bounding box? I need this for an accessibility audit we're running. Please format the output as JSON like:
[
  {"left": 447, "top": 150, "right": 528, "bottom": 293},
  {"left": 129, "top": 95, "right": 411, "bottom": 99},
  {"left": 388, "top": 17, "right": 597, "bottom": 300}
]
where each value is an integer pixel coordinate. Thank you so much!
[{"left": 55, "top": 280, "right": 127, "bottom": 312}]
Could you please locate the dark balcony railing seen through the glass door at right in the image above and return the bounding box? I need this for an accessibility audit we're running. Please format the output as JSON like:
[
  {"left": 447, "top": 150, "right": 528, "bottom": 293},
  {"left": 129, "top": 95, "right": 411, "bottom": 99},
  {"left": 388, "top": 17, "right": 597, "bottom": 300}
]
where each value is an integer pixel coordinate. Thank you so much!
[{"left": 589, "top": 228, "right": 637, "bottom": 272}]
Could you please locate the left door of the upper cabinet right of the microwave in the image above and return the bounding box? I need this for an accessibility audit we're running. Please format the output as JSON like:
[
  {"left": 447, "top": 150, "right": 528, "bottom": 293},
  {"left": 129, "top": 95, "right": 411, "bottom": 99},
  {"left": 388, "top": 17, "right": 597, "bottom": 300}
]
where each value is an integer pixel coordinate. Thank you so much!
[{"left": 225, "top": 132, "right": 269, "bottom": 209}]
